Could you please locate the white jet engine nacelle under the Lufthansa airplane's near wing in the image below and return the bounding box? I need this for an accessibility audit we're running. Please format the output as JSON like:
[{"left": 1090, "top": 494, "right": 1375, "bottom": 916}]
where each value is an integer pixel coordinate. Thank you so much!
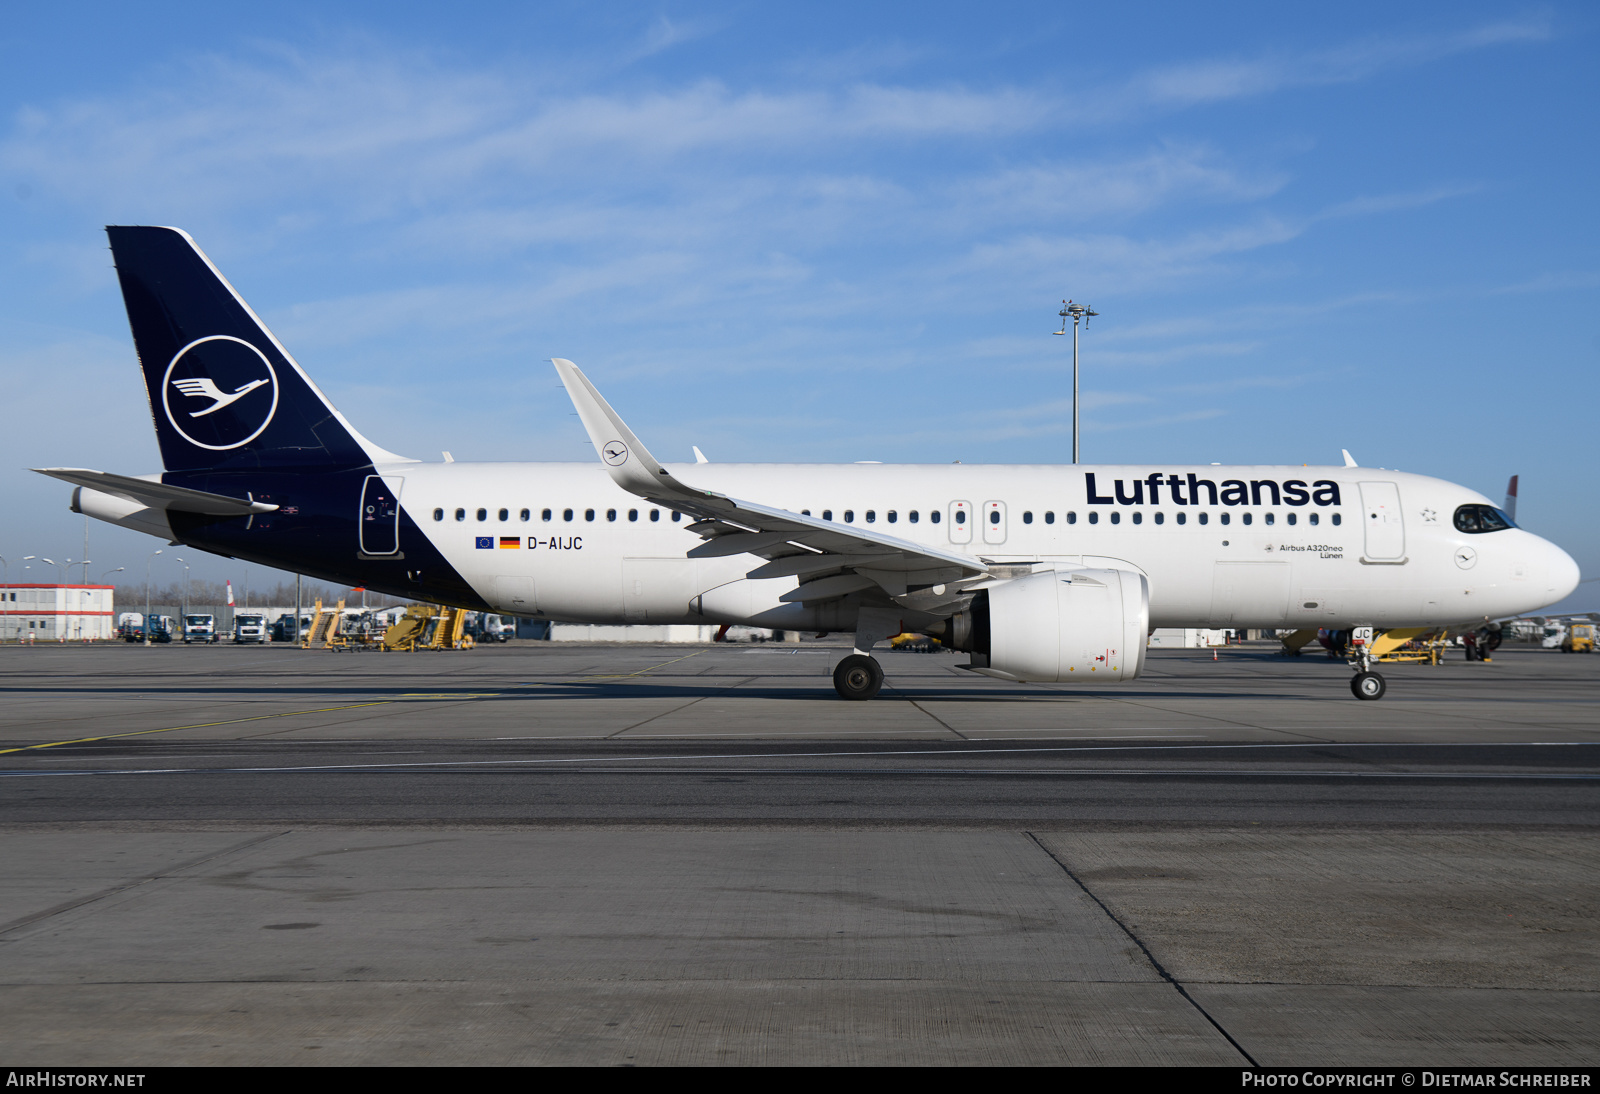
[{"left": 952, "top": 569, "right": 1150, "bottom": 685}]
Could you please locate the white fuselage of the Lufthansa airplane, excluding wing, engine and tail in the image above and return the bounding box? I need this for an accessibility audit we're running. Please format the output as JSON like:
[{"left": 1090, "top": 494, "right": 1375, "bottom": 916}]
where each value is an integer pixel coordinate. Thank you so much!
[{"left": 379, "top": 462, "right": 1578, "bottom": 629}]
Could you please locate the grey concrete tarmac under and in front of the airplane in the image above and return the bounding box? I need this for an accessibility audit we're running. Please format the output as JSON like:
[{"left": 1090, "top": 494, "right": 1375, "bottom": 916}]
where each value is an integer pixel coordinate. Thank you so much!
[{"left": 0, "top": 643, "right": 1600, "bottom": 1067}]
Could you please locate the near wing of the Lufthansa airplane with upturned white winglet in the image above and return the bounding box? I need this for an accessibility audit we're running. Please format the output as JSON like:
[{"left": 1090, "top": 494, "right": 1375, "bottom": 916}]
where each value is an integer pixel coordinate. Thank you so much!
[{"left": 552, "top": 358, "right": 989, "bottom": 601}]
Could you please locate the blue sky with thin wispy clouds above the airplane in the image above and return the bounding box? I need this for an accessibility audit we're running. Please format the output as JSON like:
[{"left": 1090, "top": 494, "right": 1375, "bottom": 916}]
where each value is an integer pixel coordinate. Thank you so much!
[{"left": 0, "top": 3, "right": 1600, "bottom": 608}]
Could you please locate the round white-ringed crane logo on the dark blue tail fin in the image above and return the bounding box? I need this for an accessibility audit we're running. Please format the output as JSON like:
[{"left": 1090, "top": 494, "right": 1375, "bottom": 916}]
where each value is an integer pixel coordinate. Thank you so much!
[{"left": 162, "top": 334, "right": 278, "bottom": 451}]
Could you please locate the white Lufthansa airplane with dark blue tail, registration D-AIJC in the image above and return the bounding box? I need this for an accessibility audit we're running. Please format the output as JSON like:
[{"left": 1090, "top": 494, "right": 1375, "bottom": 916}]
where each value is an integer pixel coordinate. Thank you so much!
[{"left": 35, "top": 227, "right": 1579, "bottom": 701}]
